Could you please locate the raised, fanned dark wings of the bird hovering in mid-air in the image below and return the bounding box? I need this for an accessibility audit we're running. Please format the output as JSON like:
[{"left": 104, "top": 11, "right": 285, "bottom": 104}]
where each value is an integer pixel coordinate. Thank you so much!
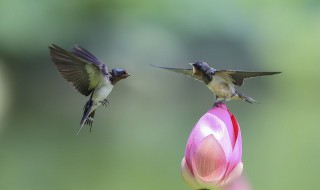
[{"left": 49, "top": 44, "right": 108, "bottom": 96}]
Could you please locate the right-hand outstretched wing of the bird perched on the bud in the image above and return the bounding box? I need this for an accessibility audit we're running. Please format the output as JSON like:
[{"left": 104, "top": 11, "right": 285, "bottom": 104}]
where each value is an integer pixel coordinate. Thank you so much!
[{"left": 215, "top": 70, "right": 281, "bottom": 86}]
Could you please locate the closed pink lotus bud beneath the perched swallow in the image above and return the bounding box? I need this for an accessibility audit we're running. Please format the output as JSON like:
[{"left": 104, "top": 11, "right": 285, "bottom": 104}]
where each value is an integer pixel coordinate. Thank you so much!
[{"left": 181, "top": 103, "right": 243, "bottom": 190}]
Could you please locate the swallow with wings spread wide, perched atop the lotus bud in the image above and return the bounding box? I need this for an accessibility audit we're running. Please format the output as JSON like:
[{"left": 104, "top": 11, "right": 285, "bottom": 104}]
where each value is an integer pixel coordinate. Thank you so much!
[{"left": 152, "top": 61, "right": 281, "bottom": 105}]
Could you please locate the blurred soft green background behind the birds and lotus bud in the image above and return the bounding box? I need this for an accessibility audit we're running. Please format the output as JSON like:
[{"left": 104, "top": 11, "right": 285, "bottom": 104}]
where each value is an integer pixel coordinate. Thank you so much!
[{"left": 0, "top": 0, "right": 320, "bottom": 190}]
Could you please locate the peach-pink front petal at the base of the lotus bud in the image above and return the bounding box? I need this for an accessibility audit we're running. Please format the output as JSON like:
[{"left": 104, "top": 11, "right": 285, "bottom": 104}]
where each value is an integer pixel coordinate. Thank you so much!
[{"left": 192, "top": 134, "right": 227, "bottom": 187}]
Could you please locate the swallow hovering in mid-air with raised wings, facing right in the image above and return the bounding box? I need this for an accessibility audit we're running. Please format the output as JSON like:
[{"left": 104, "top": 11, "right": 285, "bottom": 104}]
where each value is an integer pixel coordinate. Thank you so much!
[{"left": 49, "top": 44, "right": 130, "bottom": 134}]
